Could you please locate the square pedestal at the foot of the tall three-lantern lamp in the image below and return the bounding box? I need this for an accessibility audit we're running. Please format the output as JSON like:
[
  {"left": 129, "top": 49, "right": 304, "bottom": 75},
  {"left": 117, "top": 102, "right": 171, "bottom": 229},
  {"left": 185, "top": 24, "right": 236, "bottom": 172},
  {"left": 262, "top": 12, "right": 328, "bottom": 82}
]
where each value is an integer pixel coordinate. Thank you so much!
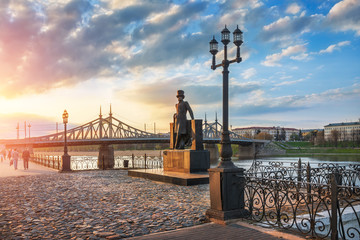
[{"left": 206, "top": 168, "right": 249, "bottom": 223}]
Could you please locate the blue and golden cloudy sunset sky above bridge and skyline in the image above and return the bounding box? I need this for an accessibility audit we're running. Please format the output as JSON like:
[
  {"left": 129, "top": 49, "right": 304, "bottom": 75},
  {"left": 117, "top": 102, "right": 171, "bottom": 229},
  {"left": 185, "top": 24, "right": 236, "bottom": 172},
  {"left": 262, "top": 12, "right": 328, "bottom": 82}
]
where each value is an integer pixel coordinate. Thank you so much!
[{"left": 0, "top": 0, "right": 360, "bottom": 139}]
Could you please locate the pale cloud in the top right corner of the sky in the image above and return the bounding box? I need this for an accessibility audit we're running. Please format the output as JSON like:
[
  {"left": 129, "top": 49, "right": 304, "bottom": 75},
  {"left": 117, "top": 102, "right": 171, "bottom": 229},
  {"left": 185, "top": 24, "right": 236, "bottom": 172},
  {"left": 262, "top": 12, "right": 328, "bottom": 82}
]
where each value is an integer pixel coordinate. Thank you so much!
[{"left": 326, "top": 0, "right": 360, "bottom": 36}]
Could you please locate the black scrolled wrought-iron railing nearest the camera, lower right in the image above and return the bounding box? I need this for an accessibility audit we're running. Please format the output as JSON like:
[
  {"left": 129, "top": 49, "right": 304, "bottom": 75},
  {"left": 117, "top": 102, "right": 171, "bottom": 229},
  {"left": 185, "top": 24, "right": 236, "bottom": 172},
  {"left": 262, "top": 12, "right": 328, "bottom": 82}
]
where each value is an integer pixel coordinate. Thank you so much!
[{"left": 244, "top": 173, "right": 360, "bottom": 239}]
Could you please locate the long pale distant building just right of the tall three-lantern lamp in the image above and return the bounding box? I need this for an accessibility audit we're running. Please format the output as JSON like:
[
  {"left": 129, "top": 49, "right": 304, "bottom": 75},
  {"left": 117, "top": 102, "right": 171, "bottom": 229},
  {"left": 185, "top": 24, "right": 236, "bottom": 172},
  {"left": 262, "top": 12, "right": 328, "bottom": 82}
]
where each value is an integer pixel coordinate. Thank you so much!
[{"left": 232, "top": 127, "right": 300, "bottom": 141}]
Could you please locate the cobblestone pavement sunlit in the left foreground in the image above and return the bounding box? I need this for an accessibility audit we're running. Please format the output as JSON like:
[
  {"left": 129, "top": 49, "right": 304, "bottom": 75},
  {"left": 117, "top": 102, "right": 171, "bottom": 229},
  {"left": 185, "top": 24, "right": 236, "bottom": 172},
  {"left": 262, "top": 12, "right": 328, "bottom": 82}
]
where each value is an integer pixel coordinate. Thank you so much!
[{"left": 0, "top": 170, "right": 210, "bottom": 239}]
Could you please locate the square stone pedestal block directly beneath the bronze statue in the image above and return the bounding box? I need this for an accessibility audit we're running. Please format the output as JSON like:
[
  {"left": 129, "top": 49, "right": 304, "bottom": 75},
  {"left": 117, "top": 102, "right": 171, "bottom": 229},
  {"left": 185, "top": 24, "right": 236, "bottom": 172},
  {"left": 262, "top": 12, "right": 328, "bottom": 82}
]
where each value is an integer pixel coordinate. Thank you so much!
[{"left": 163, "top": 149, "right": 210, "bottom": 173}]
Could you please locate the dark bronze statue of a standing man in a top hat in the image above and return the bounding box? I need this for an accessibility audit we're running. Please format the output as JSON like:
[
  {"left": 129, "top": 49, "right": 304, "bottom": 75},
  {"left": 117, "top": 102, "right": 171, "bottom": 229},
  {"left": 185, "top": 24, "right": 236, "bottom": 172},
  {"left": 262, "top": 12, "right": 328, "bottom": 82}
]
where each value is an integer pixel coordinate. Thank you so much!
[{"left": 174, "top": 90, "right": 194, "bottom": 149}]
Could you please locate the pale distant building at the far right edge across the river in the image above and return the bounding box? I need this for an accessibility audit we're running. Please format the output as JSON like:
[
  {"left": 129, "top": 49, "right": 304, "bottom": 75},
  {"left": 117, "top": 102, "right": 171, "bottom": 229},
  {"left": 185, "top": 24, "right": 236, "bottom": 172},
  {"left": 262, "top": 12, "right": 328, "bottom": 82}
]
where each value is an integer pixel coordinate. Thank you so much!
[{"left": 324, "top": 120, "right": 360, "bottom": 141}]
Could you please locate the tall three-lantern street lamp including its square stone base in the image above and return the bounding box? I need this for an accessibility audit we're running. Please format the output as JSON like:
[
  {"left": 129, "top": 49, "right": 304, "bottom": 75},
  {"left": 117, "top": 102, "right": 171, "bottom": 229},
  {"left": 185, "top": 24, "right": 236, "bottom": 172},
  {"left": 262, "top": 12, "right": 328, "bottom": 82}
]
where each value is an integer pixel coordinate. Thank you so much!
[{"left": 206, "top": 25, "right": 249, "bottom": 222}]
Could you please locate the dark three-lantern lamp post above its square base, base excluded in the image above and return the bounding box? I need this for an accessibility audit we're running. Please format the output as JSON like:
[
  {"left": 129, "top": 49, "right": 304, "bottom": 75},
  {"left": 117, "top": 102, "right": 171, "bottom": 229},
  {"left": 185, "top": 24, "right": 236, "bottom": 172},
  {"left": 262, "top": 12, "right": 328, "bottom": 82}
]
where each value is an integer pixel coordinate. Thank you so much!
[{"left": 210, "top": 25, "right": 243, "bottom": 168}]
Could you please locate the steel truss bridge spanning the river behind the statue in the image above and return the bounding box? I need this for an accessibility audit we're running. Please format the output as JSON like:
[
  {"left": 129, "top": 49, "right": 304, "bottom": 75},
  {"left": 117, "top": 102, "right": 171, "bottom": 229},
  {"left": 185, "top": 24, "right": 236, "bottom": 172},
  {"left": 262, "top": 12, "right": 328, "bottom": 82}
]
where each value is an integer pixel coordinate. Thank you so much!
[{"left": 0, "top": 109, "right": 268, "bottom": 148}]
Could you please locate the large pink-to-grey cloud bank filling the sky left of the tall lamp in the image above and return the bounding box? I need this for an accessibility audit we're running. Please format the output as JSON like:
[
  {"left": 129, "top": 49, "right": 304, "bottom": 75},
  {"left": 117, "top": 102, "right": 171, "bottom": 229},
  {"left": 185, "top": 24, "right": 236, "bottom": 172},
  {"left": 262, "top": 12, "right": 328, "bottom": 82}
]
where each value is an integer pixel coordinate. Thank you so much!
[{"left": 0, "top": 0, "right": 212, "bottom": 98}]
